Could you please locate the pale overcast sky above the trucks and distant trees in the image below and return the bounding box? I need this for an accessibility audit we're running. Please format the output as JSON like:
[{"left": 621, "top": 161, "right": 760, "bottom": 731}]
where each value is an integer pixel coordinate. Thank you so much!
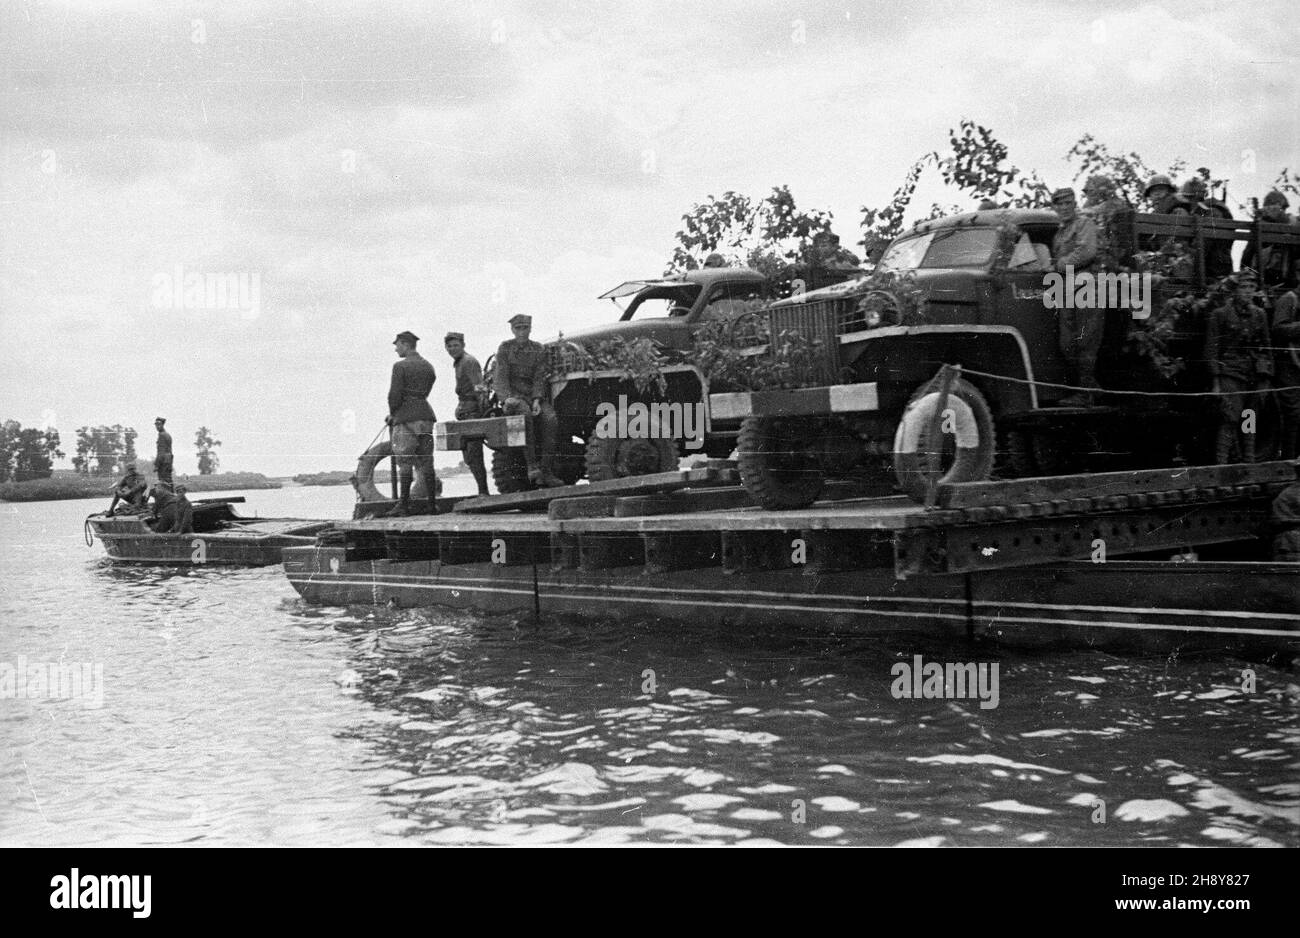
[{"left": 0, "top": 0, "right": 1300, "bottom": 474}]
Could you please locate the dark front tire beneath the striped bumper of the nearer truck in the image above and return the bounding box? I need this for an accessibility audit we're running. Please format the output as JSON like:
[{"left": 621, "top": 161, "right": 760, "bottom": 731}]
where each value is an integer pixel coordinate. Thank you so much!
[{"left": 736, "top": 417, "right": 826, "bottom": 511}]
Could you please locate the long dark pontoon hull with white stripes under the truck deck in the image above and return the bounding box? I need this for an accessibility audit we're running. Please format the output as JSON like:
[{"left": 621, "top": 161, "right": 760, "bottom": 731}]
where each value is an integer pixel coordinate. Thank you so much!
[{"left": 283, "top": 544, "right": 1300, "bottom": 653}]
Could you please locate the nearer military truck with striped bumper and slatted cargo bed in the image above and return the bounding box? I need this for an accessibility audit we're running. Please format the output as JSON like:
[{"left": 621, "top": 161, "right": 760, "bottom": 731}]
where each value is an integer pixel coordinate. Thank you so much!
[{"left": 711, "top": 209, "right": 1300, "bottom": 509}]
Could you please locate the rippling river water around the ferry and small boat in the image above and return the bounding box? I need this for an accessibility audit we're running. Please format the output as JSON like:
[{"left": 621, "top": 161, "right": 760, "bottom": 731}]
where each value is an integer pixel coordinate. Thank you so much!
[{"left": 0, "top": 479, "right": 1300, "bottom": 847}]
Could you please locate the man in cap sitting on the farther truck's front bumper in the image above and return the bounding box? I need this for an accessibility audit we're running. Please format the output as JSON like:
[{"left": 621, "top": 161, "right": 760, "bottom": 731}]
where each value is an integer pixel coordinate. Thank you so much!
[{"left": 493, "top": 313, "right": 564, "bottom": 488}]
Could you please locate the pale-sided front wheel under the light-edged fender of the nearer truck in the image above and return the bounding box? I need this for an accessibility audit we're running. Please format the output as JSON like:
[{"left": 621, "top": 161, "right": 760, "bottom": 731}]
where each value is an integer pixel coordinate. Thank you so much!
[{"left": 894, "top": 378, "right": 997, "bottom": 501}]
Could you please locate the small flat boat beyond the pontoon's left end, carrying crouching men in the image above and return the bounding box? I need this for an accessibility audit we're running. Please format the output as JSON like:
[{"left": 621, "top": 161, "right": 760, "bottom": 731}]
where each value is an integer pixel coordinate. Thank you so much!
[{"left": 86, "top": 496, "right": 334, "bottom": 566}]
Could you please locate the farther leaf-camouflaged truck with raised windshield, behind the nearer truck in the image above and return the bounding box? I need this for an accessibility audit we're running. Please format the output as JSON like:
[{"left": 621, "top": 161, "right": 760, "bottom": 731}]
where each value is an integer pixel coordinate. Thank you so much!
[{"left": 436, "top": 268, "right": 771, "bottom": 492}]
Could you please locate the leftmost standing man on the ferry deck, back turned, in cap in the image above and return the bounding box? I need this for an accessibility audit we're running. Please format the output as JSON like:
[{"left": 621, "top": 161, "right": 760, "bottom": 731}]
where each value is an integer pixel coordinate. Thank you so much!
[{"left": 385, "top": 331, "right": 438, "bottom": 517}]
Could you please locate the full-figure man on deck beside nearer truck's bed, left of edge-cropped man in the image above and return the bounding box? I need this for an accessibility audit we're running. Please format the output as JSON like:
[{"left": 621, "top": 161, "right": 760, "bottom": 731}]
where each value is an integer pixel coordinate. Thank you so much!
[{"left": 1205, "top": 269, "right": 1273, "bottom": 465}]
